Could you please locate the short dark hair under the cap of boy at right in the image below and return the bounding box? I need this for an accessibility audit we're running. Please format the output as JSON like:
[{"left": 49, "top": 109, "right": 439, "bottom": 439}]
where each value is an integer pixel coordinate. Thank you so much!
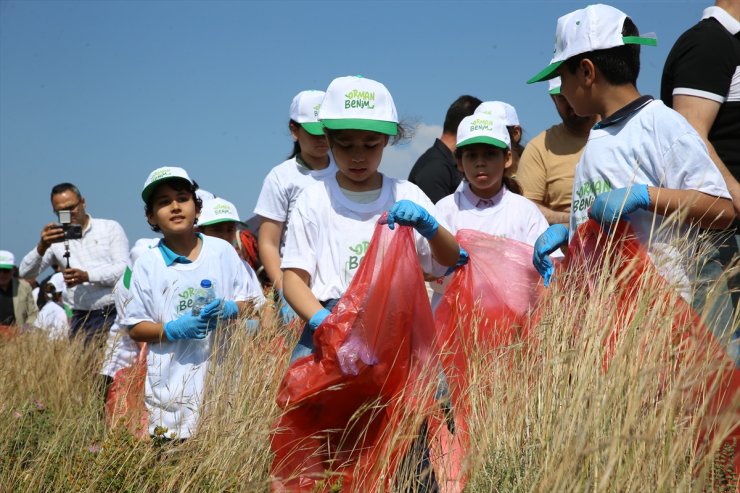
[{"left": 563, "top": 17, "right": 640, "bottom": 86}]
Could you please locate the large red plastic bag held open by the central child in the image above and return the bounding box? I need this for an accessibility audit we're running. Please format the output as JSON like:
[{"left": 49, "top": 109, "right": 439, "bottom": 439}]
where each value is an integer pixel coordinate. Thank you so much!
[{"left": 271, "top": 219, "right": 436, "bottom": 491}]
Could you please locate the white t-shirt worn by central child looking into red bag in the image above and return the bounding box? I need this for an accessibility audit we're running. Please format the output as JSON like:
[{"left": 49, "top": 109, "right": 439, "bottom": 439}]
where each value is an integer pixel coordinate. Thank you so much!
[{"left": 281, "top": 175, "right": 447, "bottom": 301}]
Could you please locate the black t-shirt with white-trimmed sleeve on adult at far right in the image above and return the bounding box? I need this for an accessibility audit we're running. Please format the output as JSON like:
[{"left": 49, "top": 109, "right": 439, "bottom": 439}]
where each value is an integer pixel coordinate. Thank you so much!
[{"left": 660, "top": 17, "right": 740, "bottom": 180}]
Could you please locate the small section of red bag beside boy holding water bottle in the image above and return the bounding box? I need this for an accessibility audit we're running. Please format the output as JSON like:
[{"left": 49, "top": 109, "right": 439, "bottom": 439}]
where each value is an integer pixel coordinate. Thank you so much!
[{"left": 105, "top": 345, "right": 149, "bottom": 439}]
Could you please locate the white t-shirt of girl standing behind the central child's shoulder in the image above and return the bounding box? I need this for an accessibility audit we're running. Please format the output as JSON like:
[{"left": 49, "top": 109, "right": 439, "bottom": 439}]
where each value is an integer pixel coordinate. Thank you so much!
[{"left": 254, "top": 152, "right": 337, "bottom": 255}]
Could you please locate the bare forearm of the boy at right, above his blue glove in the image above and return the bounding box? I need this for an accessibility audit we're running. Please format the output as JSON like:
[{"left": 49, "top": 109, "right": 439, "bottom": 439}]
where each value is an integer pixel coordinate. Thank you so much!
[{"left": 648, "top": 187, "right": 735, "bottom": 229}]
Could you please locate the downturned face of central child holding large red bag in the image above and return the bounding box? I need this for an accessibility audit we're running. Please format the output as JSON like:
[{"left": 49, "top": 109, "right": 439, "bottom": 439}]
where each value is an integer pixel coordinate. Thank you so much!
[{"left": 331, "top": 130, "right": 388, "bottom": 192}]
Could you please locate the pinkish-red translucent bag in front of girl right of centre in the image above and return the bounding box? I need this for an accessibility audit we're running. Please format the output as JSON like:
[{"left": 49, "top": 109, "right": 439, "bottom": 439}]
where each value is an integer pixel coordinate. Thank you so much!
[{"left": 430, "top": 230, "right": 543, "bottom": 491}]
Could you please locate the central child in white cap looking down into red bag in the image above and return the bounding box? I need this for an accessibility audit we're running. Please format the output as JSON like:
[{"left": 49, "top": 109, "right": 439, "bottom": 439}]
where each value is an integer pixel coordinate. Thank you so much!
[{"left": 282, "top": 77, "right": 460, "bottom": 370}]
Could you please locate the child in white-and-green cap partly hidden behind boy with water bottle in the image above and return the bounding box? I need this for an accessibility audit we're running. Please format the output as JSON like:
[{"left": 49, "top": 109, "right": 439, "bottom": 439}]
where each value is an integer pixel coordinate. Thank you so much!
[{"left": 198, "top": 198, "right": 271, "bottom": 326}]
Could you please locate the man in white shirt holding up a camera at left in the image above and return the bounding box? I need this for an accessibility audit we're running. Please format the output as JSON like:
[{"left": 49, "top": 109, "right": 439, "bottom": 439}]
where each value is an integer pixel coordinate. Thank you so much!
[{"left": 20, "top": 183, "right": 129, "bottom": 344}]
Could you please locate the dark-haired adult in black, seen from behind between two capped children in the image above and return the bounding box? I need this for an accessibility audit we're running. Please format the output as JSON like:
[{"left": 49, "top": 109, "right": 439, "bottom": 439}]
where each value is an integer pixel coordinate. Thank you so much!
[{"left": 409, "top": 95, "right": 481, "bottom": 204}]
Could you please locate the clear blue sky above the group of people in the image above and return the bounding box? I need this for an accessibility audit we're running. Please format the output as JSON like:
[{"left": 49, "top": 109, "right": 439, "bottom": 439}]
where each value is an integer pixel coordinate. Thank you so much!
[{"left": 0, "top": 0, "right": 710, "bottom": 270}]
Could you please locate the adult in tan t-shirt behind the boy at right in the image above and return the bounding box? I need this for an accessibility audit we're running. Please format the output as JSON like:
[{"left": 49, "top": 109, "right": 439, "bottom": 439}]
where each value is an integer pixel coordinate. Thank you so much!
[{"left": 516, "top": 77, "right": 599, "bottom": 224}]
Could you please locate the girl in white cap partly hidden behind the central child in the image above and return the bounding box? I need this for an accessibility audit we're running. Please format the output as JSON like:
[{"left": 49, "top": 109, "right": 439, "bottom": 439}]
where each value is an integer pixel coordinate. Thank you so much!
[{"left": 254, "top": 91, "right": 336, "bottom": 323}]
